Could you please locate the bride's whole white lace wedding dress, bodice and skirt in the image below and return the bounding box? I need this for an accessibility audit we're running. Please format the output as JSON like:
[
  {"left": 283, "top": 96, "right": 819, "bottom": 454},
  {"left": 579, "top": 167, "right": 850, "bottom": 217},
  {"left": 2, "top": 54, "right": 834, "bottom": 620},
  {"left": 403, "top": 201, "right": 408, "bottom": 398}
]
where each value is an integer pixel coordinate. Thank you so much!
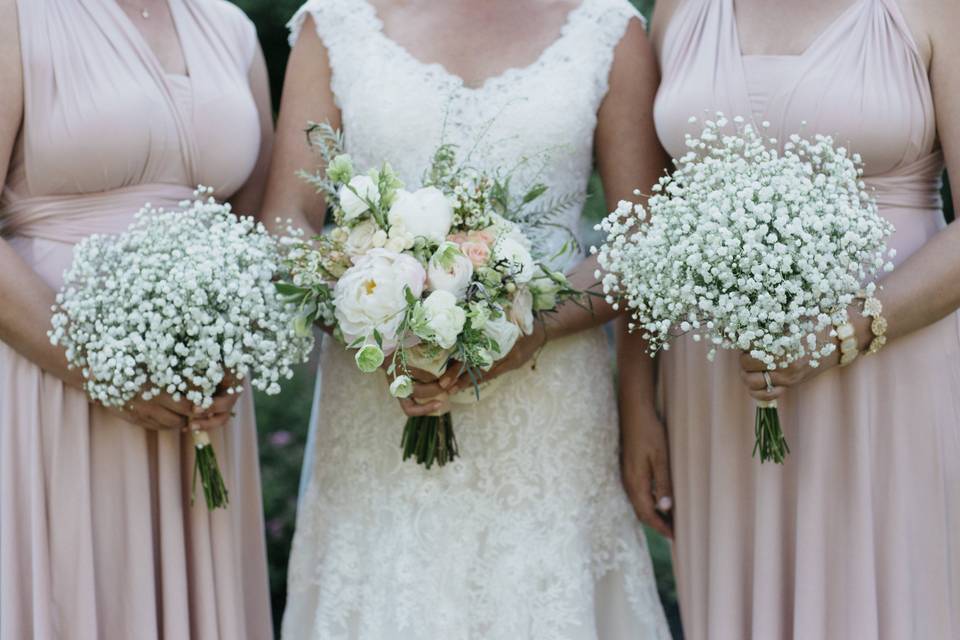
[{"left": 283, "top": 0, "right": 669, "bottom": 640}]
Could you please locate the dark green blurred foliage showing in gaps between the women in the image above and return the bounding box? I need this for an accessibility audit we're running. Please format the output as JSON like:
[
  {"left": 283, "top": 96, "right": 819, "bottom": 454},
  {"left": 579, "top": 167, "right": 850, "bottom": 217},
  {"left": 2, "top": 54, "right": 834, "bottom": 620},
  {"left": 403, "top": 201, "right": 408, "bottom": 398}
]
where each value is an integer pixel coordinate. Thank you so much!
[{"left": 233, "top": 0, "right": 953, "bottom": 638}]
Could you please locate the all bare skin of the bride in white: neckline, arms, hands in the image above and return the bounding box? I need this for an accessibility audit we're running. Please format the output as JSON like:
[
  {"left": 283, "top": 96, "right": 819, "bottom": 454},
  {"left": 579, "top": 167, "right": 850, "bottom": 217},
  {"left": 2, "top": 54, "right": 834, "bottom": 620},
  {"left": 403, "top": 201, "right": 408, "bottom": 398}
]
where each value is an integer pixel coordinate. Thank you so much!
[{"left": 263, "top": 0, "right": 669, "bottom": 533}]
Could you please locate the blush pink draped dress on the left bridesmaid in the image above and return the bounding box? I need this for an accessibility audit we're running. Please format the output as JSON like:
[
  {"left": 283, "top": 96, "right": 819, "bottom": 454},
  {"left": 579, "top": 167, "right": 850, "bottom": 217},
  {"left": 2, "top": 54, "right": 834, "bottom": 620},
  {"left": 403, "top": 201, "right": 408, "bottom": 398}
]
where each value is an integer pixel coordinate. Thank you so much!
[{"left": 0, "top": 0, "right": 271, "bottom": 640}]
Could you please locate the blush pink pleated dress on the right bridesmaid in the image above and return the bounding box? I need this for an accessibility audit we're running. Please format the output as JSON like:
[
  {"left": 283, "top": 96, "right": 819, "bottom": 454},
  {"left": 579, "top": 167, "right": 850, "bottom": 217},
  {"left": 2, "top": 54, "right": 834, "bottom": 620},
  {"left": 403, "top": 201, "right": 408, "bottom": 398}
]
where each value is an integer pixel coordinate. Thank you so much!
[{"left": 655, "top": 0, "right": 960, "bottom": 640}]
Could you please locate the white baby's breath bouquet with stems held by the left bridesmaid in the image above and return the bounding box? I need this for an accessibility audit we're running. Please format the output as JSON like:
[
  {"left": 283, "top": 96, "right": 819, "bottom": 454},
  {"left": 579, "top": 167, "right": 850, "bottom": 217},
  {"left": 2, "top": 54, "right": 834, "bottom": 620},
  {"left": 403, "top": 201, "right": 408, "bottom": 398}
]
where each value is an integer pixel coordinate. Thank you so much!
[{"left": 49, "top": 188, "right": 313, "bottom": 510}]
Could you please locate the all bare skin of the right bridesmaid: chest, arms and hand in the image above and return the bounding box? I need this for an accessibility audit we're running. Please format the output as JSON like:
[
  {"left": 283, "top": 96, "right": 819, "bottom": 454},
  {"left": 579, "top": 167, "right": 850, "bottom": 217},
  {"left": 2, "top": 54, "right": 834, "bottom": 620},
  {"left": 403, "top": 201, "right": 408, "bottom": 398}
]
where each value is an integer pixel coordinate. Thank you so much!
[{"left": 652, "top": 0, "right": 960, "bottom": 400}]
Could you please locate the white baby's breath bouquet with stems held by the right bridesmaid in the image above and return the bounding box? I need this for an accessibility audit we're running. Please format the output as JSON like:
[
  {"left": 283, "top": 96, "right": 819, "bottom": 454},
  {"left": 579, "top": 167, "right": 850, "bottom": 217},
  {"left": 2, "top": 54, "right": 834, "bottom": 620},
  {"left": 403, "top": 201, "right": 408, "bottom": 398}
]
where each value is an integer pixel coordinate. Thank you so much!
[{"left": 598, "top": 114, "right": 893, "bottom": 463}]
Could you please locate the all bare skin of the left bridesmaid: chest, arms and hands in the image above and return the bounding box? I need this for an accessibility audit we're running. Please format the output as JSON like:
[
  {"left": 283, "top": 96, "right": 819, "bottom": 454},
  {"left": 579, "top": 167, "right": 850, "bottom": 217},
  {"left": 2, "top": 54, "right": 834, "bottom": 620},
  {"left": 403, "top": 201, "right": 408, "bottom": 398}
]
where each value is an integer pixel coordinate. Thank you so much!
[{"left": 0, "top": 0, "right": 273, "bottom": 430}]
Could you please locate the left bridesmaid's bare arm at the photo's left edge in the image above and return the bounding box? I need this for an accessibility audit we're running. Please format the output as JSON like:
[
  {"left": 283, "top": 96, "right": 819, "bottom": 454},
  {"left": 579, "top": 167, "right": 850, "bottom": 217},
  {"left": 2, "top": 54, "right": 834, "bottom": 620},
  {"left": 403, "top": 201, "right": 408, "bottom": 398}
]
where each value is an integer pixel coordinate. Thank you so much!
[{"left": 0, "top": 0, "right": 82, "bottom": 388}]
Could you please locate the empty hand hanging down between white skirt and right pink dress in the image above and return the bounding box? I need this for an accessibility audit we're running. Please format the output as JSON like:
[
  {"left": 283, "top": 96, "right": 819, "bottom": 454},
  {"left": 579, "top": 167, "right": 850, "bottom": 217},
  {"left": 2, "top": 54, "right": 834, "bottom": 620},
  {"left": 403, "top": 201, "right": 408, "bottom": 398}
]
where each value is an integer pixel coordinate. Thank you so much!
[{"left": 621, "top": 413, "right": 673, "bottom": 538}]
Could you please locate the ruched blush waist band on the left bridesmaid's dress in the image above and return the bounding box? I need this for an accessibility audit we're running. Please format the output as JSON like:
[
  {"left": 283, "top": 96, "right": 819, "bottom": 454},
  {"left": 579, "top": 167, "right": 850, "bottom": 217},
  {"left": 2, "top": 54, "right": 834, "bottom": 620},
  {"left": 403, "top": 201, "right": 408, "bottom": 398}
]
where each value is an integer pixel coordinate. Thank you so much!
[{"left": 0, "top": 184, "right": 193, "bottom": 244}]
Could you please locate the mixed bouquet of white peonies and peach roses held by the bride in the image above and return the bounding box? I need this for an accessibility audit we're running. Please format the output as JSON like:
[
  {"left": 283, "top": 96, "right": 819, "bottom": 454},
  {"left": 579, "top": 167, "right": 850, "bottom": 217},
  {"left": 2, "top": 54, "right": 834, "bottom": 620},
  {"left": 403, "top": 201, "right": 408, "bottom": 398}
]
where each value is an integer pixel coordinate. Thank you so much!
[{"left": 278, "top": 125, "right": 579, "bottom": 468}]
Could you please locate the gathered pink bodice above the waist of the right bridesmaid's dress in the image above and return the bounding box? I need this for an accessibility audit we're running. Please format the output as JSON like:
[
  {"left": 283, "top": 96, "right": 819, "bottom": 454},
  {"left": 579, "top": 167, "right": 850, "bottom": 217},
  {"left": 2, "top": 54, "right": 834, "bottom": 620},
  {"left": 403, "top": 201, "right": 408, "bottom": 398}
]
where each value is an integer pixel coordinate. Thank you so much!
[{"left": 655, "top": 0, "right": 936, "bottom": 177}]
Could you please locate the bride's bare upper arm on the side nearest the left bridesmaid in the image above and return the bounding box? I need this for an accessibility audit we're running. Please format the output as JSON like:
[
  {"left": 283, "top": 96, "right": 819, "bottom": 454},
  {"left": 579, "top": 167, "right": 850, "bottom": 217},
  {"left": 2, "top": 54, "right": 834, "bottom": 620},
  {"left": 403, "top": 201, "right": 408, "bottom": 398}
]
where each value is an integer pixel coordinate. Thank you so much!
[{"left": 263, "top": 17, "right": 340, "bottom": 232}]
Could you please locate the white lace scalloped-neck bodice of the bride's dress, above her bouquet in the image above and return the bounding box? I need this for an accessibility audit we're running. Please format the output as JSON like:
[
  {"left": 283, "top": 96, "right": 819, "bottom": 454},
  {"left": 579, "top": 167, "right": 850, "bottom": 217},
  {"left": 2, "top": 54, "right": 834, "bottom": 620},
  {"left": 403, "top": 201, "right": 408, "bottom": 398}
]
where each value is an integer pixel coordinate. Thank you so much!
[{"left": 290, "top": 0, "right": 642, "bottom": 267}]
